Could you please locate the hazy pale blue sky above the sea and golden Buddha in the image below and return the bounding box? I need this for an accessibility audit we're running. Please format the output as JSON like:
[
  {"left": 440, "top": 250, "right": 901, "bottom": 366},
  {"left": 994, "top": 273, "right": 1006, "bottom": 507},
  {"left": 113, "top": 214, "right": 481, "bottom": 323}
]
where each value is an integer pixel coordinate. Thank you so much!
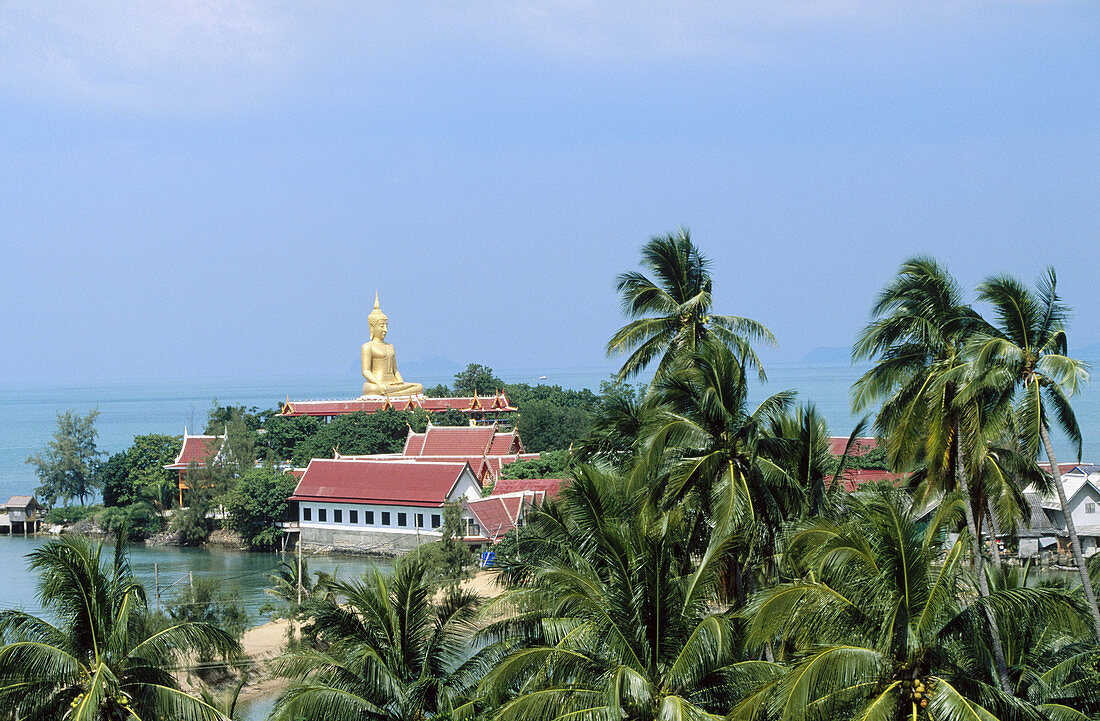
[{"left": 0, "top": 0, "right": 1100, "bottom": 386}]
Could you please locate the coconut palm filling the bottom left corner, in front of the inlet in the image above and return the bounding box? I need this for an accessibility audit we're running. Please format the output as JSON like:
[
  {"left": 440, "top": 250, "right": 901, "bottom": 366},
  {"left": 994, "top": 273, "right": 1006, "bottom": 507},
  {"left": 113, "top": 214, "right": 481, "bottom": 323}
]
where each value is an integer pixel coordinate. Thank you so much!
[{"left": 0, "top": 532, "right": 240, "bottom": 721}]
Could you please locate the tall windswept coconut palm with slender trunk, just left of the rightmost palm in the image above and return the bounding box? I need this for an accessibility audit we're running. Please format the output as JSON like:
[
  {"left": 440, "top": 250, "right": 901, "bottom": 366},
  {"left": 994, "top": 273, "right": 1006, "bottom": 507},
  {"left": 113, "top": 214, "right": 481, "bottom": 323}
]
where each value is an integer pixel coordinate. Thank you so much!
[{"left": 853, "top": 258, "right": 1011, "bottom": 691}]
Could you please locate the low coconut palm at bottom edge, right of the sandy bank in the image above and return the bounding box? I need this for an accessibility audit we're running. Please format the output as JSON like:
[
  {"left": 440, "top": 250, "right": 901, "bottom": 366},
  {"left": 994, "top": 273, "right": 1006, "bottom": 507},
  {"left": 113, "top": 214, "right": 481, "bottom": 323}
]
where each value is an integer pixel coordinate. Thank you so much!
[{"left": 272, "top": 556, "right": 485, "bottom": 721}]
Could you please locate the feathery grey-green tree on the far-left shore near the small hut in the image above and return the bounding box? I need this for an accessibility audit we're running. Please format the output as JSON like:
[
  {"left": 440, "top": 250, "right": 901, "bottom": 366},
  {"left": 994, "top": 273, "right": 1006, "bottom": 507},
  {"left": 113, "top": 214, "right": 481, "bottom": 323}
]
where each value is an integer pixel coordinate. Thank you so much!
[{"left": 26, "top": 408, "right": 102, "bottom": 506}]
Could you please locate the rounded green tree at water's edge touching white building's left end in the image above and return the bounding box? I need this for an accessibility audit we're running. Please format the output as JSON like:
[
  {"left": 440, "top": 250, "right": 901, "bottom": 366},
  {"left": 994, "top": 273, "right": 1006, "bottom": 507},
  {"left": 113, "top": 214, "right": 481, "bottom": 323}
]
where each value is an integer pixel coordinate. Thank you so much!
[{"left": 226, "top": 468, "right": 298, "bottom": 549}]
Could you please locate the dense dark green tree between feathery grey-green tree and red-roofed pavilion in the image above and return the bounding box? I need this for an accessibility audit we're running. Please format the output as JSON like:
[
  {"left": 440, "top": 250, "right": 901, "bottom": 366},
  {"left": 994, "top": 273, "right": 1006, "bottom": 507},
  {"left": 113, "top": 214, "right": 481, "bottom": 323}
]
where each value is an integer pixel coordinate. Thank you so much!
[{"left": 99, "top": 434, "right": 183, "bottom": 509}]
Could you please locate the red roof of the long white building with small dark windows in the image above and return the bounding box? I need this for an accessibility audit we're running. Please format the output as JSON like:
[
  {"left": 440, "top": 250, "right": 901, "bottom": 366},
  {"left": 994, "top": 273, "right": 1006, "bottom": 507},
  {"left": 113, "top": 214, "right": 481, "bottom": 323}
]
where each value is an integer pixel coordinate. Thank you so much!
[{"left": 290, "top": 458, "right": 468, "bottom": 506}]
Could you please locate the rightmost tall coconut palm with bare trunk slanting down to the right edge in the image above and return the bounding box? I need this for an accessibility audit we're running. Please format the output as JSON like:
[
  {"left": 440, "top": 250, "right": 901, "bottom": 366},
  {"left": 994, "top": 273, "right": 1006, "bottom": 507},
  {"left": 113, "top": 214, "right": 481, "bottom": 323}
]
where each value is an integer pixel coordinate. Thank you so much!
[{"left": 972, "top": 267, "right": 1100, "bottom": 636}]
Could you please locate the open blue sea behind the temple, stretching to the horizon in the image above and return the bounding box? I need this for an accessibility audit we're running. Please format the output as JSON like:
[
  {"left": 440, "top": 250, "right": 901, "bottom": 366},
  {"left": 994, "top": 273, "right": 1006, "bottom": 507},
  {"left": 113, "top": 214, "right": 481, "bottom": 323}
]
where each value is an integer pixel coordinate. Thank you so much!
[{"left": 0, "top": 357, "right": 1100, "bottom": 508}]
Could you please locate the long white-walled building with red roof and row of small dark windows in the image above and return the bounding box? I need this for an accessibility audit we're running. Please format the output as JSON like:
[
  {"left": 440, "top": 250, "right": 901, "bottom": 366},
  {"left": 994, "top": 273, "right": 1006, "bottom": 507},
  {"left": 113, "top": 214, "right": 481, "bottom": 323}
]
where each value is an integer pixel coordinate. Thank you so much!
[{"left": 289, "top": 458, "right": 482, "bottom": 554}]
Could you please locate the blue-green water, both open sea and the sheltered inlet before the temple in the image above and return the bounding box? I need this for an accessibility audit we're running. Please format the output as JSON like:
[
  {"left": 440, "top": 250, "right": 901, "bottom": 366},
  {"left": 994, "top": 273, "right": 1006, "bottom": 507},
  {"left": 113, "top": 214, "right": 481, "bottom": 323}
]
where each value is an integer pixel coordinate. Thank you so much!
[{"left": 0, "top": 360, "right": 1100, "bottom": 721}]
